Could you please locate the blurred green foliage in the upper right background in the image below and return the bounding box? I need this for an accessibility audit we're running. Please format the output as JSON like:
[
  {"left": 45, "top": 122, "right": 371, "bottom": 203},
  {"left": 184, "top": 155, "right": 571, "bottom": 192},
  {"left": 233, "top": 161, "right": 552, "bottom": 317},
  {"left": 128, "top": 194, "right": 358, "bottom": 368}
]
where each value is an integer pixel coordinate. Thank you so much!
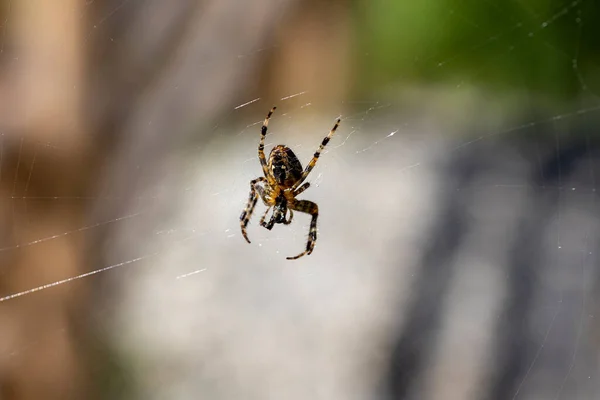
[{"left": 355, "top": 0, "right": 600, "bottom": 99}]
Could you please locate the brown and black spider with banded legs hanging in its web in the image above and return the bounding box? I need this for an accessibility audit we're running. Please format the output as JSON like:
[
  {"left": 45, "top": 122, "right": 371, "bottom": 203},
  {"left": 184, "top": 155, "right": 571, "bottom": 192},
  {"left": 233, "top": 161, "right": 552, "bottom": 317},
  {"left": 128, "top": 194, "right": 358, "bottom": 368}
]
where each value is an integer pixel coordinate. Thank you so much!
[{"left": 240, "top": 107, "right": 341, "bottom": 260}]
